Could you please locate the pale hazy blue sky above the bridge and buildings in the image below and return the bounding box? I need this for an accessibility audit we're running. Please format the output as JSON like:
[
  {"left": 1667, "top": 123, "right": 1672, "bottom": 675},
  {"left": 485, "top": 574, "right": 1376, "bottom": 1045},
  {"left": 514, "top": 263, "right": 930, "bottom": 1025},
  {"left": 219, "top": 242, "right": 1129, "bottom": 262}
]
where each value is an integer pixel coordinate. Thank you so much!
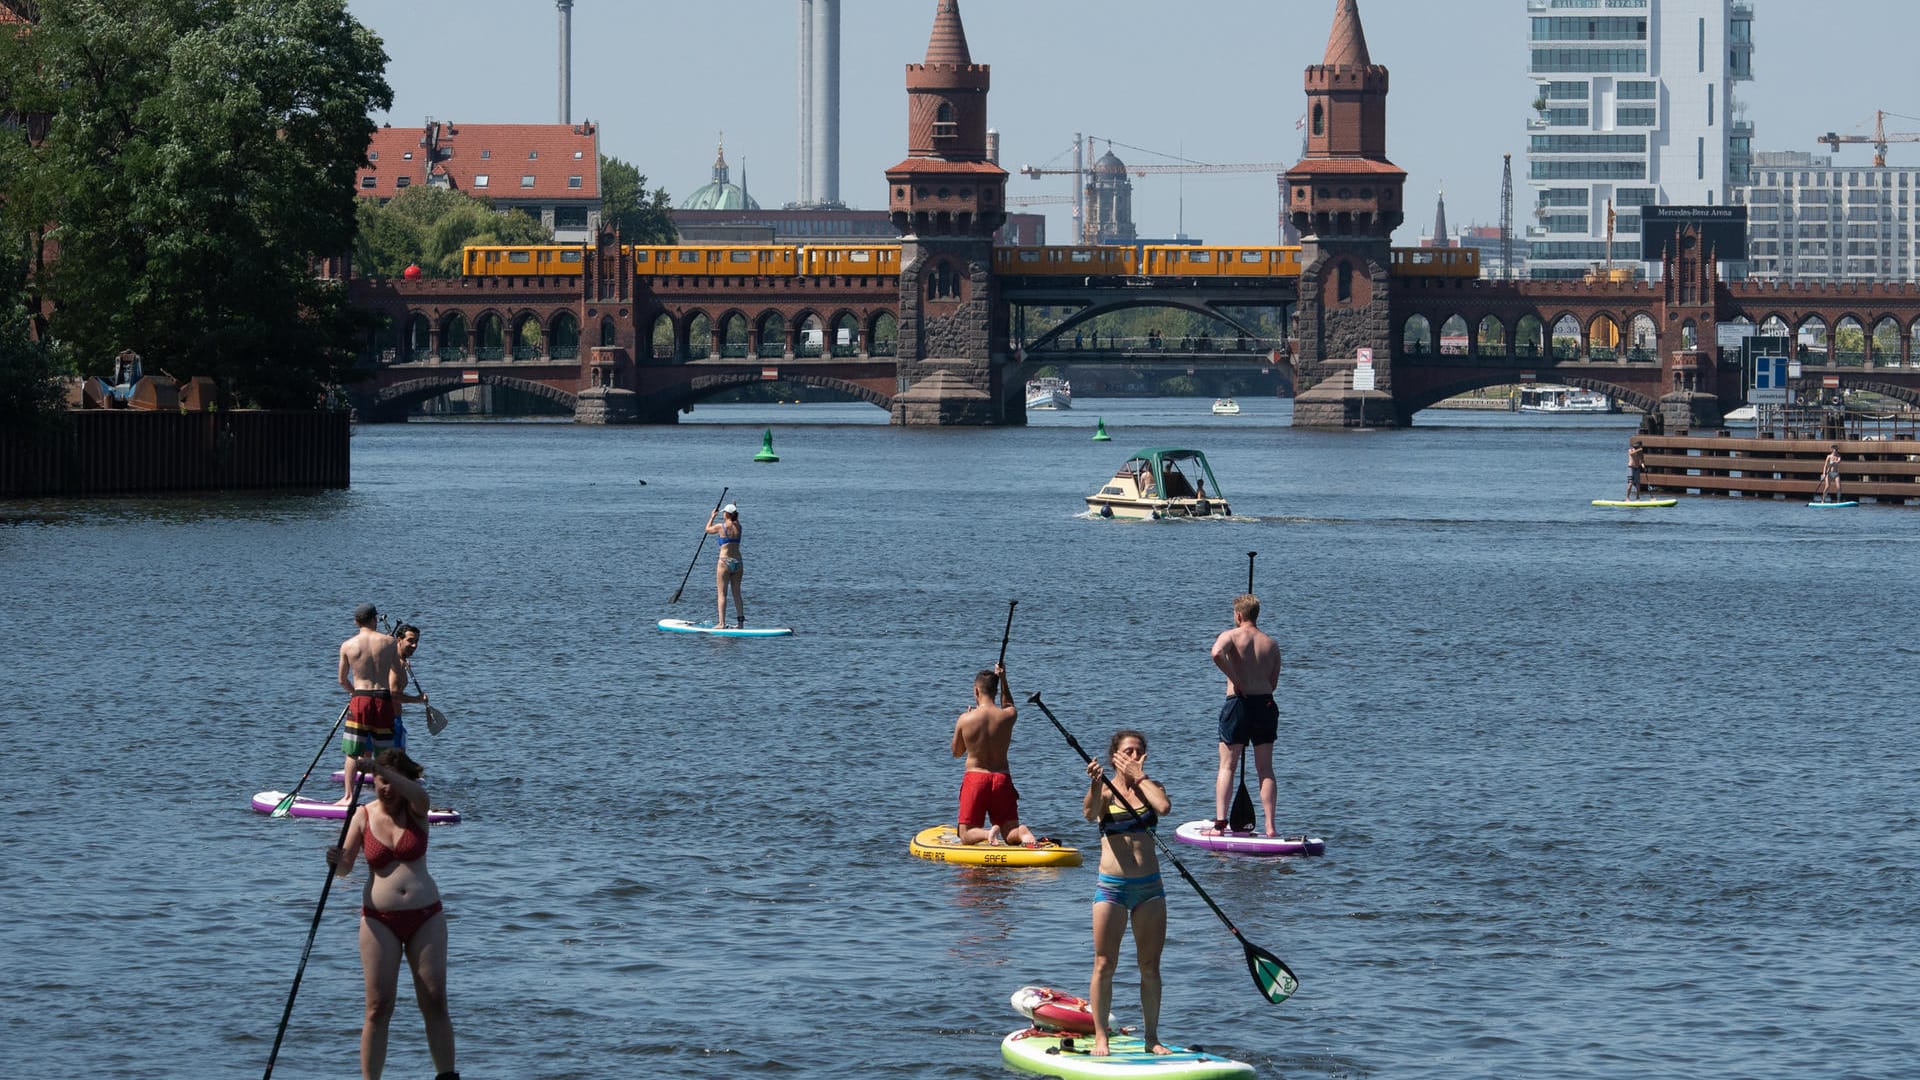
[{"left": 349, "top": 0, "right": 1920, "bottom": 244}]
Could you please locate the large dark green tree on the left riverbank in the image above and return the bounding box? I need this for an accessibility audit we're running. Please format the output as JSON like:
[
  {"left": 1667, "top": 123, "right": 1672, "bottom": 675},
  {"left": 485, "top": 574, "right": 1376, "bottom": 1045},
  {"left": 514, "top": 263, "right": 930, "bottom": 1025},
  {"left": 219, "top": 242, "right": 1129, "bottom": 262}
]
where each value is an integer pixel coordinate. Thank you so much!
[{"left": 0, "top": 0, "right": 394, "bottom": 407}]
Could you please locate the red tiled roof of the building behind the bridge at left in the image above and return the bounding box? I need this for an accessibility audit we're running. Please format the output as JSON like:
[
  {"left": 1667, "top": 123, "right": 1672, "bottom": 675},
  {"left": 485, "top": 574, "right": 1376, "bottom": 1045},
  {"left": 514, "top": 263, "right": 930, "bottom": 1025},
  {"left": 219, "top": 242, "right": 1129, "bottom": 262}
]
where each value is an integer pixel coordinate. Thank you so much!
[{"left": 353, "top": 121, "right": 601, "bottom": 204}]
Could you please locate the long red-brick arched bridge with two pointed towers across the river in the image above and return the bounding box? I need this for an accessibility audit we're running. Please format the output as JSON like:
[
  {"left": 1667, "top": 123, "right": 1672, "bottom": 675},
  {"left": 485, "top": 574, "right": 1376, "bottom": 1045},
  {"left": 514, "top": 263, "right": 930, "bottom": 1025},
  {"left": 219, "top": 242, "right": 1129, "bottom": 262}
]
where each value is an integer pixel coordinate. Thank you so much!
[{"left": 349, "top": 0, "right": 1920, "bottom": 432}]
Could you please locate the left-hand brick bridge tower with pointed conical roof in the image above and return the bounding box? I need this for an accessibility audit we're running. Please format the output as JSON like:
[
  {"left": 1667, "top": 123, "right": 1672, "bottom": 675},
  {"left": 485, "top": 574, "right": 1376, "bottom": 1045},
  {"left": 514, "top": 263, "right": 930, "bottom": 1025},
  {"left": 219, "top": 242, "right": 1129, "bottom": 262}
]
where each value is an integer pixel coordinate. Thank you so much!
[{"left": 887, "top": 0, "right": 1025, "bottom": 425}]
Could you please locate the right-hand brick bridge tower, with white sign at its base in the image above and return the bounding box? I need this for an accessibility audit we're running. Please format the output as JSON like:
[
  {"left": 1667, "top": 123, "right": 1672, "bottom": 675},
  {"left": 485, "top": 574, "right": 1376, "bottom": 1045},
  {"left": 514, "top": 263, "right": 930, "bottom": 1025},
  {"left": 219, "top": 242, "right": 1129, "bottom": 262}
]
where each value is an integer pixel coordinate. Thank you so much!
[{"left": 1286, "top": 0, "right": 1407, "bottom": 429}]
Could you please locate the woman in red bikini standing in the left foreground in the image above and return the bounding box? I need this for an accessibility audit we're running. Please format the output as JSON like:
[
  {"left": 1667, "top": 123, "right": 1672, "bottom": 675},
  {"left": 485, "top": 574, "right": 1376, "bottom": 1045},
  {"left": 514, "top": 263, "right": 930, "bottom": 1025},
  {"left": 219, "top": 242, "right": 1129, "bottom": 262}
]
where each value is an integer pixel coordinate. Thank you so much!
[{"left": 326, "top": 749, "right": 459, "bottom": 1080}]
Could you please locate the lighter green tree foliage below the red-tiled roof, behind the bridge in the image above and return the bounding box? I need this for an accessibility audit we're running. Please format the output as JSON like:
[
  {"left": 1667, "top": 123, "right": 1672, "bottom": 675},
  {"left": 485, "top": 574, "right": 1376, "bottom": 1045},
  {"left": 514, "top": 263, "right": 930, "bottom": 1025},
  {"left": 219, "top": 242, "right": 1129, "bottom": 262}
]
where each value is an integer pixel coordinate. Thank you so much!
[{"left": 353, "top": 186, "right": 553, "bottom": 277}]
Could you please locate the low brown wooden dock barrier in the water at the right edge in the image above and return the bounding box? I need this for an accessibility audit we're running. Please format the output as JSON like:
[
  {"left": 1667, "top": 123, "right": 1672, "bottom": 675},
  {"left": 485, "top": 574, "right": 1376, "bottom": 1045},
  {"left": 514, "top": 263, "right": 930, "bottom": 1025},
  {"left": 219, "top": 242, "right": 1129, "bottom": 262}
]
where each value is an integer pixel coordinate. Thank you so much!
[{"left": 1632, "top": 430, "right": 1920, "bottom": 503}]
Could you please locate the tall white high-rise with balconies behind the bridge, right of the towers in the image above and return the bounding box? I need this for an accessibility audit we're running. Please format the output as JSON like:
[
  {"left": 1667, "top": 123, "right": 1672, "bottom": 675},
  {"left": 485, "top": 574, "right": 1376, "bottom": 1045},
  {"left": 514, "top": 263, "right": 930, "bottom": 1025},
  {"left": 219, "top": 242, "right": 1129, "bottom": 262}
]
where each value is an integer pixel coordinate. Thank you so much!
[{"left": 1526, "top": 0, "right": 1753, "bottom": 279}]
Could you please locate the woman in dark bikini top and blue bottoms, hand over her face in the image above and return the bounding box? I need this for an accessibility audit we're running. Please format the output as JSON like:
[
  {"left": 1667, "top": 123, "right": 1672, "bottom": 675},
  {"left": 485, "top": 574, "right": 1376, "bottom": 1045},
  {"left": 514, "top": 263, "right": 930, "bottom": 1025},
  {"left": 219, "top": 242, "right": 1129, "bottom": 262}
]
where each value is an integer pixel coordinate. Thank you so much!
[{"left": 1081, "top": 728, "right": 1173, "bottom": 1057}]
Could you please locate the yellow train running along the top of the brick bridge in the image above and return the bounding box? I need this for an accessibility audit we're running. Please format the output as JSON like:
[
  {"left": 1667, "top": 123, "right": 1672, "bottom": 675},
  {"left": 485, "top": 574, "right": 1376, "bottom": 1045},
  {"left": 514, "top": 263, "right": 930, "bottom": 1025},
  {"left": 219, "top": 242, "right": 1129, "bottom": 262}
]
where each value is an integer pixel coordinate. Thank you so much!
[{"left": 461, "top": 244, "right": 1480, "bottom": 279}]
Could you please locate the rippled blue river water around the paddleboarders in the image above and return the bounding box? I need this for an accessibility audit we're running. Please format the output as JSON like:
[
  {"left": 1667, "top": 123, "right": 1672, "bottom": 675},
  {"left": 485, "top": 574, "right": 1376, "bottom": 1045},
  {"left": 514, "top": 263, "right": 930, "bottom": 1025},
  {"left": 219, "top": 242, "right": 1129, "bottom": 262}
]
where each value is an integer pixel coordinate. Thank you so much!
[{"left": 0, "top": 398, "right": 1920, "bottom": 1078}]
